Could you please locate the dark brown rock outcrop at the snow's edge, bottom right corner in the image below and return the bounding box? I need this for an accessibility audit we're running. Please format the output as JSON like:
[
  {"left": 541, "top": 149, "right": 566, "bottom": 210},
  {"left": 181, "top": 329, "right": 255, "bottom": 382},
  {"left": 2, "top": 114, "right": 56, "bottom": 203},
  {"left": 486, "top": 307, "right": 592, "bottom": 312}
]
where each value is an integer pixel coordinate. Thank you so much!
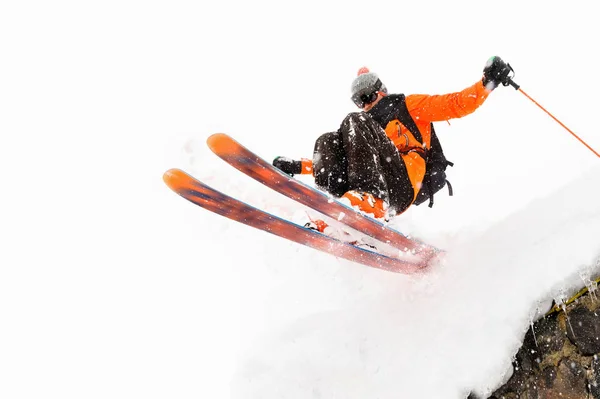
[{"left": 489, "top": 292, "right": 600, "bottom": 399}]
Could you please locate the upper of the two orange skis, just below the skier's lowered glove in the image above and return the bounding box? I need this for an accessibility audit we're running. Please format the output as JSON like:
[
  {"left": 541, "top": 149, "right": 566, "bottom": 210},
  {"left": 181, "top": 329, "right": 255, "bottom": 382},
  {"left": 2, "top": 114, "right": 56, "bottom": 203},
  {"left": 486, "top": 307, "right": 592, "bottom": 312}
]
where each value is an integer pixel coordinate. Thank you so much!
[{"left": 207, "top": 133, "right": 440, "bottom": 259}]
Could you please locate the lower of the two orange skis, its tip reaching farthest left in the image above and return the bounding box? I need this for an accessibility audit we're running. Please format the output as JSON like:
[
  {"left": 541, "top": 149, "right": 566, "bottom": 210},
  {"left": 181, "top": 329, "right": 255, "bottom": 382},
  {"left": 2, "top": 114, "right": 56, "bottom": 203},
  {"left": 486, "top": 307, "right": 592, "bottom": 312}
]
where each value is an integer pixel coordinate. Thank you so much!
[{"left": 163, "top": 169, "right": 428, "bottom": 274}]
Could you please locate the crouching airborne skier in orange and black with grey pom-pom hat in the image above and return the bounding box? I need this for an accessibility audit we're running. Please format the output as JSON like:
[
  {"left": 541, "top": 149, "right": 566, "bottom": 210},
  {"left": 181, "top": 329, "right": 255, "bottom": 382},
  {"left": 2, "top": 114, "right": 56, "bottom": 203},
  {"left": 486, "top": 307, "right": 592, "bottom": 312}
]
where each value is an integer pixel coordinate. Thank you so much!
[{"left": 273, "top": 57, "right": 512, "bottom": 219}]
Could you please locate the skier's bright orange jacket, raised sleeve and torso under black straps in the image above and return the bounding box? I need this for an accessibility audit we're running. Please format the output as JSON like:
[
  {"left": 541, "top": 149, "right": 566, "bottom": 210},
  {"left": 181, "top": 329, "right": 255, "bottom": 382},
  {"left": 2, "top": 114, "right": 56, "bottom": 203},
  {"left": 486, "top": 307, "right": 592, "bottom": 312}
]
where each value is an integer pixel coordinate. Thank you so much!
[{"left": 385, "top": 81, "right": 490, "bottom": 206}]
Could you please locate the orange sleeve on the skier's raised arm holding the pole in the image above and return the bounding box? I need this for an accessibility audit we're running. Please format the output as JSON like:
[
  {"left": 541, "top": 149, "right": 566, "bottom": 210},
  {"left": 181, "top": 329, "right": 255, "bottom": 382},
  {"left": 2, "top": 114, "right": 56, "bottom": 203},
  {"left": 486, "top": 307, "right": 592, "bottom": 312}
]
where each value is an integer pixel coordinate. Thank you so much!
[{"left": 406, "top": 81, "right": 490, "bottom": 122}]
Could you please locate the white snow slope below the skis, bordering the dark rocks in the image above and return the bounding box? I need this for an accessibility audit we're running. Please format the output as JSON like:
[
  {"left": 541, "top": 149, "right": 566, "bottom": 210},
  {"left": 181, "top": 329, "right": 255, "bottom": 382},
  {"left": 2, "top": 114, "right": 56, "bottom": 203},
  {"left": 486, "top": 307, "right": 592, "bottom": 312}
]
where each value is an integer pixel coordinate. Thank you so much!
[{"left": 225, "top": 164, "right": 600, "bottom": 398}]
